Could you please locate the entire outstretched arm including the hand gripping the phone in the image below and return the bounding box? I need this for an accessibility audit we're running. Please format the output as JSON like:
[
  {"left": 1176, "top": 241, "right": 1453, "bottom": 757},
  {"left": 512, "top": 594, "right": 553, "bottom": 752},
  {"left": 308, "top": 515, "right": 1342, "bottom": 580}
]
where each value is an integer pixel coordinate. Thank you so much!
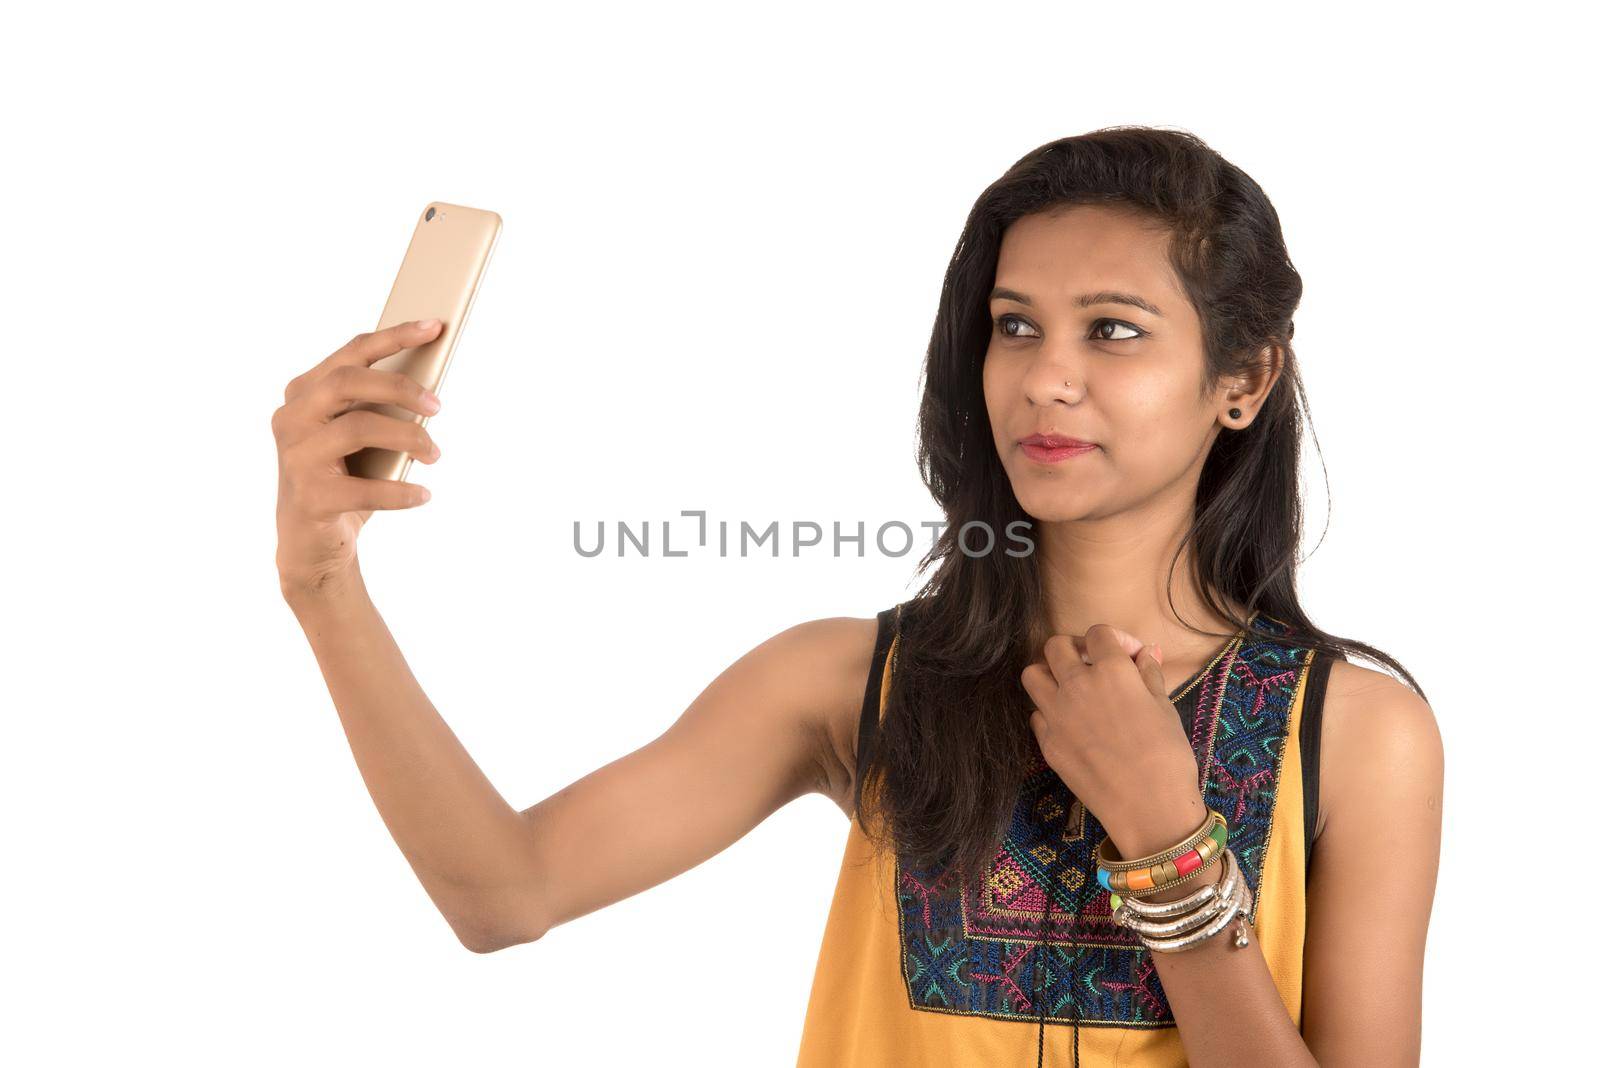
[{"left": 272, "top": 325, "right": 875, "bottom": 953}]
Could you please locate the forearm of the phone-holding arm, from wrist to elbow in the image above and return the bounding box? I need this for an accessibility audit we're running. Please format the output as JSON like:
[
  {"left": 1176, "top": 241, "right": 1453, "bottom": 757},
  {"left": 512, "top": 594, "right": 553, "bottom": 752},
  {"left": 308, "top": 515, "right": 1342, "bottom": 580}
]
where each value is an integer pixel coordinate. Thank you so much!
[{"left": 285, "top": 574, "right": 536, "bottom": 950}]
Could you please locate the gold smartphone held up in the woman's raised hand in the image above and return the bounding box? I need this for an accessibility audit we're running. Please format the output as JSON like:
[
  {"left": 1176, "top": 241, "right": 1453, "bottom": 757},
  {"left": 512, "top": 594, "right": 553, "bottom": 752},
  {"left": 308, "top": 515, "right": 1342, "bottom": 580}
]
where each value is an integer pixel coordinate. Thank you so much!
[{"left": 344, "top": 200, "right": 501, "bottom": 481}]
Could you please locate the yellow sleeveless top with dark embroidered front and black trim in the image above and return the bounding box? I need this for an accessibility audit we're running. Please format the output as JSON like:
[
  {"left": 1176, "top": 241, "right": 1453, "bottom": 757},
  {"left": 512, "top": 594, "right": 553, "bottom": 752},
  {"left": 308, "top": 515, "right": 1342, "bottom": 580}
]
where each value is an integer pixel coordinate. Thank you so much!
[{"left": 798, "top": 606, "right": 1331, "bottom": 1068}]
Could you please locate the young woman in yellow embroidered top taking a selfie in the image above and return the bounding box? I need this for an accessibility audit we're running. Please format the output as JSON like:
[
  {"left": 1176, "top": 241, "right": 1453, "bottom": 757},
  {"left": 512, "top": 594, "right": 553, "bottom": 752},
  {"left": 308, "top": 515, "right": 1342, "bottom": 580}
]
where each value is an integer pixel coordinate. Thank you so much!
[{"left": 272, "top": 128, "right": 1443, "bottom": 1068}]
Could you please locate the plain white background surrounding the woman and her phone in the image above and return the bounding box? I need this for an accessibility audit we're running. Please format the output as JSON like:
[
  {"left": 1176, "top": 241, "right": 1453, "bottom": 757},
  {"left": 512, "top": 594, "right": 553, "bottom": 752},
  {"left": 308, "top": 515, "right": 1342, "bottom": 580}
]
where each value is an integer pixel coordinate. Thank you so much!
[{"left": 0, "top": 3, "right": 1597, "bottom": 1065}]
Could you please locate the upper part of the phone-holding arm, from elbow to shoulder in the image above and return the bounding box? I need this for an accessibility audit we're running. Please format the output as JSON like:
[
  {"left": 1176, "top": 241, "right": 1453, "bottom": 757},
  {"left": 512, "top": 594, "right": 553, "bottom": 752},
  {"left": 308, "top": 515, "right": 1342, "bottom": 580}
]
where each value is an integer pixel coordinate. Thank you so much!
[{"left": 508, "top": 617, "right": 877, "bottom": 943}]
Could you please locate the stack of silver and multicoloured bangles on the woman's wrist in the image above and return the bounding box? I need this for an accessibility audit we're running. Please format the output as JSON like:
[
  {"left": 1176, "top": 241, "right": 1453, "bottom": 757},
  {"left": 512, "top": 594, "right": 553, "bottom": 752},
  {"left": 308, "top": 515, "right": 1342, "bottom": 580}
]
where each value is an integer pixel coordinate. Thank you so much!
[{"left": 1094, "top": 811, "right": 1251, "bottom": 953}]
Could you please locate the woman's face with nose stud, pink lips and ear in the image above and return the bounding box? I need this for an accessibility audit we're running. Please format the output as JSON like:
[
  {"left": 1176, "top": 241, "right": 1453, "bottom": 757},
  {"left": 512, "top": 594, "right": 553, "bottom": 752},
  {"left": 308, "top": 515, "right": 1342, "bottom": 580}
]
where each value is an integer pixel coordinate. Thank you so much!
[{"left": 984, "top": 205, "right": 1254, "bottom": 521}]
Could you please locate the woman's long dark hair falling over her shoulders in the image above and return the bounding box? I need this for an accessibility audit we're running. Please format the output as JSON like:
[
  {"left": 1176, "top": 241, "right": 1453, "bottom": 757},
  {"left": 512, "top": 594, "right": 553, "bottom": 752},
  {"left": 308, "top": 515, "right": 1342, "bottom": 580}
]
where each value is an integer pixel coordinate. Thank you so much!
[{"left": 856, "top": 126, "right": 1422, "bottom": 908}]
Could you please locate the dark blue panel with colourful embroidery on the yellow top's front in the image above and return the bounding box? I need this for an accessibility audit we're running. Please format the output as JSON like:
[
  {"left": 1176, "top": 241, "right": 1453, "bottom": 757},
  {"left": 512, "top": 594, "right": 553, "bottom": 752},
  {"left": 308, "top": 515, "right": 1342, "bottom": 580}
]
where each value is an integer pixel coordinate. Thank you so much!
[{"left": 894, "top": 616, "right": 1307, "bottom": 1028}]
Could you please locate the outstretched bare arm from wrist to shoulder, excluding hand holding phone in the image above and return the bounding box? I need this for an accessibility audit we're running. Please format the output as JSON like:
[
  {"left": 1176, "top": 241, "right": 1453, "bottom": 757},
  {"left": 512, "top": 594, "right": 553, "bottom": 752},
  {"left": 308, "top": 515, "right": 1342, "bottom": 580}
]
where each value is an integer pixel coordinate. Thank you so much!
[{"left": 290, "top": 582, "right": 875, "bottom": 953}]
